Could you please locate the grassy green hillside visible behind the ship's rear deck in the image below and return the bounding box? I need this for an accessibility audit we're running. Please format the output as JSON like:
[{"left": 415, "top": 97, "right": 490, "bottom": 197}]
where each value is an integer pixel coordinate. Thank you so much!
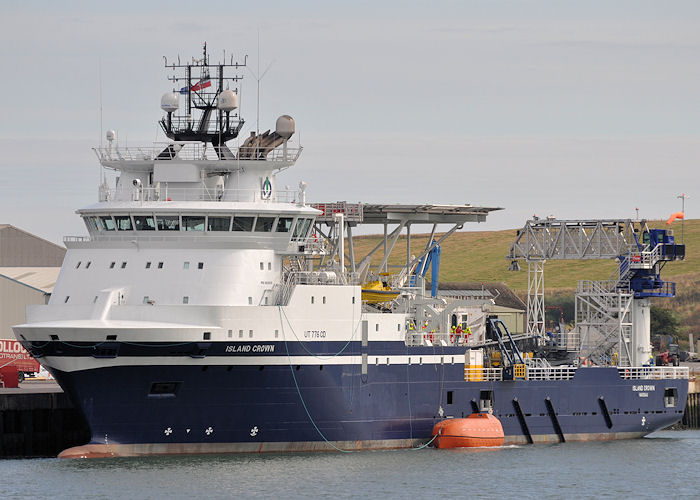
[{"left": 354, "top": 220, "right": 700, "bottom": 336}]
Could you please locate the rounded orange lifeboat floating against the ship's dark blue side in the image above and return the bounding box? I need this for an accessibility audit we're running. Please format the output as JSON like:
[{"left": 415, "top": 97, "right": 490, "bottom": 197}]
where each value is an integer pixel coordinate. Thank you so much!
[{"left": 432, "top": 413, "right": 504, "bottom": 448}]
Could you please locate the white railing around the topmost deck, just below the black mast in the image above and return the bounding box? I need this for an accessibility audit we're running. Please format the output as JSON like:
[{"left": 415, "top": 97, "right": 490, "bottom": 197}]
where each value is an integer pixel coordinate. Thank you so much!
[{"left": 93, "top": 141, "right": 303, "bottom": 163}]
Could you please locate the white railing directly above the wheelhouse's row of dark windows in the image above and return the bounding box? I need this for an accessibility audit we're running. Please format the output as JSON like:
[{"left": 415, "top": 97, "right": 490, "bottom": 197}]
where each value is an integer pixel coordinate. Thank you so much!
[{"left": 98, "top": 184, "right": 299, "bottom": 203}]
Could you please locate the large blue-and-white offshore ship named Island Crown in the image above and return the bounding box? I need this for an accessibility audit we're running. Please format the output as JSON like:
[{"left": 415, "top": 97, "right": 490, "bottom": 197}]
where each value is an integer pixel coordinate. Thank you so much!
[{"left": 14, "top": 45, "right": 688, "bottom": 457}]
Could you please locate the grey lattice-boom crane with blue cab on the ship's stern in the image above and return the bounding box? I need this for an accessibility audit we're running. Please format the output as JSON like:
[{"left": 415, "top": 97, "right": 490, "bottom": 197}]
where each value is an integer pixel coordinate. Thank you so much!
[{"left": 507, "top": 219, "right": 685, "bottom": 366}]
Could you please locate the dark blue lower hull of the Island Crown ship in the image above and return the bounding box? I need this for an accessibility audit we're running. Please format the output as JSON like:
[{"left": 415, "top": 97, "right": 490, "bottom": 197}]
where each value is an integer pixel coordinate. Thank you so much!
[{"left": 53, "top": 348, "right": 688, "bottom": 454}]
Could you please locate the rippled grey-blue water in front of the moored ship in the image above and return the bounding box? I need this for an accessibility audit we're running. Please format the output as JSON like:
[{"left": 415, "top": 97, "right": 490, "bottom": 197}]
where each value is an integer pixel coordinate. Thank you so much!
[{"left": 0, "top": 431, "right": 700, "bottom": 500}]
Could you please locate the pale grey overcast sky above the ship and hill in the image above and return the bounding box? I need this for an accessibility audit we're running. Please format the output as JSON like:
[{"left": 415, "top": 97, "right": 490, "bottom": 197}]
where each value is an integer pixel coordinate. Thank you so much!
[{"left": 0, "top": 0, "right": 700, "bottom": 243}]
